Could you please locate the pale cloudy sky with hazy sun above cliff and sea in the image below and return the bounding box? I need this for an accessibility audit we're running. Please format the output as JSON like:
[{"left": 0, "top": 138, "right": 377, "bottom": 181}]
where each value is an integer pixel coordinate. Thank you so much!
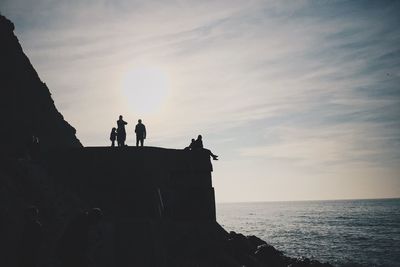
[{"left": 0, "top": 0, "right": 400, "bottom": 202}]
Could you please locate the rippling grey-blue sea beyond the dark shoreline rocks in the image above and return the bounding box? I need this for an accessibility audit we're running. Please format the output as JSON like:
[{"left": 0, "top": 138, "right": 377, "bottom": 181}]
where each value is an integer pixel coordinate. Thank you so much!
[{"left": 217, "top": 199, "right": 400, "bottom": 267}]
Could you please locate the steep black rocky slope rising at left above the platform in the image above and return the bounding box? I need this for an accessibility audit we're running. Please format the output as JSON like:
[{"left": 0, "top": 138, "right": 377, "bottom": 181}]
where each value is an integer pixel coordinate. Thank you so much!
[{"left": 0, "top": 15, "right": 82, "bottom": 156}]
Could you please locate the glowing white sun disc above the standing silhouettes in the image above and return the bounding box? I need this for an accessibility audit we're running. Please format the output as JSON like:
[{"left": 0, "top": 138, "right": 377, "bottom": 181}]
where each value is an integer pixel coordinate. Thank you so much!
[{"left": 123, "top": 67, "right": 168, "bottom": 114}]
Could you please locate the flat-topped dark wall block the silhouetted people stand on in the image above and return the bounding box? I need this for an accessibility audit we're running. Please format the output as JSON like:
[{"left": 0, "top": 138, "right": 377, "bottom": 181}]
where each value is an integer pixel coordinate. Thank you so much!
[{"left": 46, "top": 147, "right": 216, "bottom": 221}]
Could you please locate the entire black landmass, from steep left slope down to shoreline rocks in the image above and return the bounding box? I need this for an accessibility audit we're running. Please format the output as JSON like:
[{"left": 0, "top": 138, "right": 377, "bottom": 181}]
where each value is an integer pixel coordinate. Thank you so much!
[{"left": 0, "top": 16, "right": 330, "bottom": 267}]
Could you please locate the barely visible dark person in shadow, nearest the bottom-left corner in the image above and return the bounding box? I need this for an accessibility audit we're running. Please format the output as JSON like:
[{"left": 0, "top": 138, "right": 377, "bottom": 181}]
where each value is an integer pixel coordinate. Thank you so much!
[{"left": 18, "top": 206, "right": 42, "bottom": 267}]
